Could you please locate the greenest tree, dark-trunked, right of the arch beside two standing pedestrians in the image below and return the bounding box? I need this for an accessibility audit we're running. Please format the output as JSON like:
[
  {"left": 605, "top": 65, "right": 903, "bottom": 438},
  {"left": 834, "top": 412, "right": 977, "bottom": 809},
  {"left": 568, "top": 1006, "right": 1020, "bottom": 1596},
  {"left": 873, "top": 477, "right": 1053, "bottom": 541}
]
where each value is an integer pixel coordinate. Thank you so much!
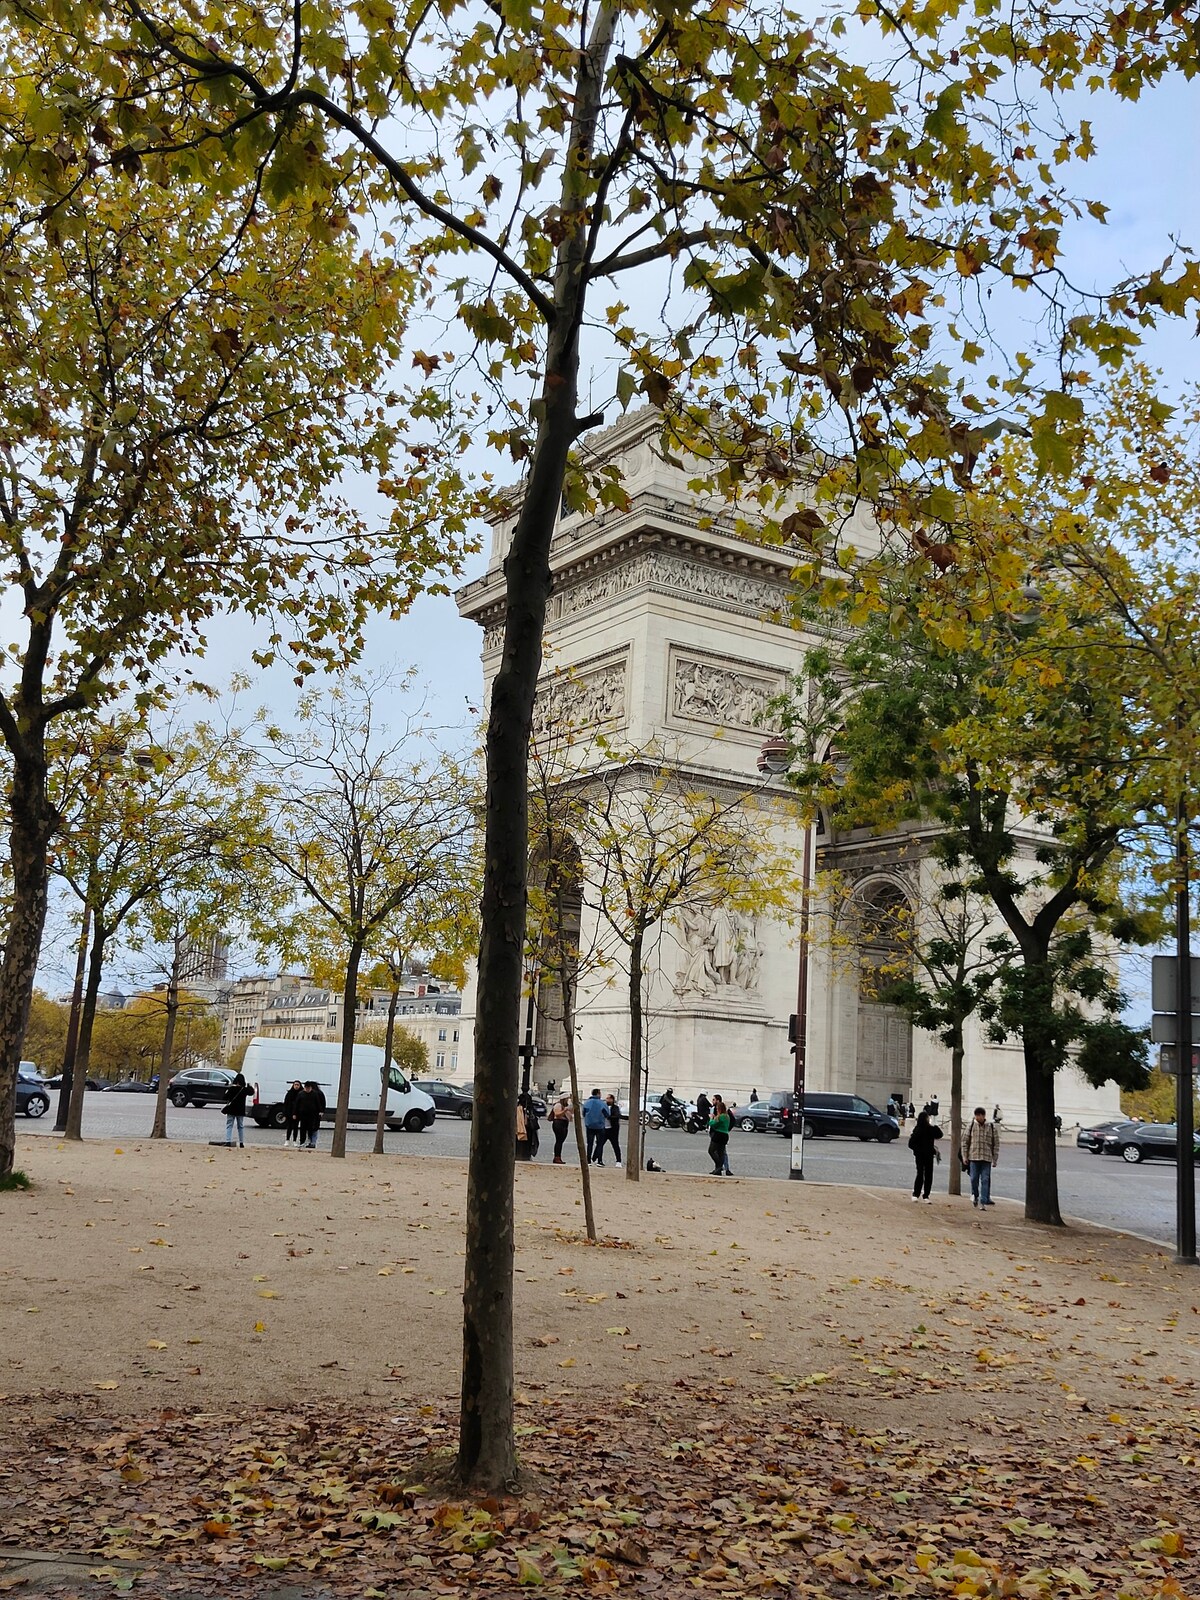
[{"left": 792, "top": 601, "right": 1154, "bottom": 1224}]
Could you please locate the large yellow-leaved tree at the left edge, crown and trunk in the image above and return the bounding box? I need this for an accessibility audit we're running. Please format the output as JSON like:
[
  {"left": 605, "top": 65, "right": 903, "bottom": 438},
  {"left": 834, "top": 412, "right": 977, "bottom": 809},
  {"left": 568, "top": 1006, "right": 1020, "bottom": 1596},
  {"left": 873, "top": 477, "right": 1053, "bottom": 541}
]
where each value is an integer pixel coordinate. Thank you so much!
[{"left": 0, "top": 37, "right": 470, "bottom": 1173}]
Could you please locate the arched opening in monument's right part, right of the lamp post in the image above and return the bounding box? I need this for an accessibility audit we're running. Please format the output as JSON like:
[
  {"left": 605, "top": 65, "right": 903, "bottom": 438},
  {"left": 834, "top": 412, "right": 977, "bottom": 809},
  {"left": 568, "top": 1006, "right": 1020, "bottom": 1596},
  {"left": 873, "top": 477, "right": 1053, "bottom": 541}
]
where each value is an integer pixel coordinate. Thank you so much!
[{"left": 854, "top": 882, "right": 912, "bottom": 1109}]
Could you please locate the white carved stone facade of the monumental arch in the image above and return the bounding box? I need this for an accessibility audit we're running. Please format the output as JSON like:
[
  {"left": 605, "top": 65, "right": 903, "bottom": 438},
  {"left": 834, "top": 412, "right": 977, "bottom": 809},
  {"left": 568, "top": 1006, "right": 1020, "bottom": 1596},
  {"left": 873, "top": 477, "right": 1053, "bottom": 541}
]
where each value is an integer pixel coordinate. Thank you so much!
[{"left": 456, "top": 413, "right": 1117, "bottom": 1126}]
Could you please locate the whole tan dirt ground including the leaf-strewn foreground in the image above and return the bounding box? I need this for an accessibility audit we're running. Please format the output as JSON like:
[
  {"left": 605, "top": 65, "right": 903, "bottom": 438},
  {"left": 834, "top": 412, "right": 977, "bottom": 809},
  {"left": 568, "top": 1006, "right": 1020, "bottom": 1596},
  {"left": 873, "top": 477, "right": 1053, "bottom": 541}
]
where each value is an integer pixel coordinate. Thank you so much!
[{"left": 0, "top": 1139, "right": 1200, "bottom": 1595}]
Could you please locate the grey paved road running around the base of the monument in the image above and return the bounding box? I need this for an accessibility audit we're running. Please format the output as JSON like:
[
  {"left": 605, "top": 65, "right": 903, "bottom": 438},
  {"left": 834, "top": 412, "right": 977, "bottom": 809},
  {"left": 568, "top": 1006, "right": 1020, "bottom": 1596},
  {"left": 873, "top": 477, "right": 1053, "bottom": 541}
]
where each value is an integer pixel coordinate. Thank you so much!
[{"left": 18, "top": 1093, "right": 1174, "bottom": 1245}]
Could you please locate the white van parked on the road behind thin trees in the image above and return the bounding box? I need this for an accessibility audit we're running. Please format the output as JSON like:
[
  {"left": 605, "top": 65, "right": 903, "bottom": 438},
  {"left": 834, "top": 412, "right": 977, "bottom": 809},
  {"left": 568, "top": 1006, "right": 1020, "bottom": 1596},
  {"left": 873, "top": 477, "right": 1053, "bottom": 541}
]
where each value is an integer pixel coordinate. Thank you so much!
[{"left": 242, "top": 1038, "right": 437, "bottom": 1133}]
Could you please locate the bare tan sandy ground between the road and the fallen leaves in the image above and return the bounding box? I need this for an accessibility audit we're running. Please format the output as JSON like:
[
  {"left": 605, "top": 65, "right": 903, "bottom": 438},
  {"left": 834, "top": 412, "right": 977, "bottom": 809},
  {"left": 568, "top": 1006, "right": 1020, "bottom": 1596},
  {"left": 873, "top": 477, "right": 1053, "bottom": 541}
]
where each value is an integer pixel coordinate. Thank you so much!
[{"left": 0, "top": 1139, "right": 1200, "bottom": 1429}]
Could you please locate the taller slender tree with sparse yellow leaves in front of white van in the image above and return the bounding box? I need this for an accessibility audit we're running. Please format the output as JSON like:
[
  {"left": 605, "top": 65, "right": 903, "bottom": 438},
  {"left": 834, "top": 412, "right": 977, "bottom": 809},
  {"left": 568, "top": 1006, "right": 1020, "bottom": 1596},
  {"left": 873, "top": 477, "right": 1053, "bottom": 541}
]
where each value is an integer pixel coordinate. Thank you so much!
[{"left": 253, "top": 677, "right": 477, "bottom": 1157}]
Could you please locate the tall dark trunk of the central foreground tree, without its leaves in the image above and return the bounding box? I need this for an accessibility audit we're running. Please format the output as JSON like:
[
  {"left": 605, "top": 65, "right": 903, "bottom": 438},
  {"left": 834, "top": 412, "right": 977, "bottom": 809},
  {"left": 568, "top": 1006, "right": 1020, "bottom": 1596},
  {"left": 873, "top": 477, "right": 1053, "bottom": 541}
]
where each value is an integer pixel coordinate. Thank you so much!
[{"left": 458, "top": 3, "right": 618, "bottom": 1494}]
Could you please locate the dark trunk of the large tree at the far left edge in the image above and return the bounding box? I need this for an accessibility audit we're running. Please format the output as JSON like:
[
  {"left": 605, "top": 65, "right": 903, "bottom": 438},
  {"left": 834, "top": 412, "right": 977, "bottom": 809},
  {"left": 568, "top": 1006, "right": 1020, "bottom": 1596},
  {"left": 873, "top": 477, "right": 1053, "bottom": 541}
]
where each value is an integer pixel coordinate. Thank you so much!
[{"left": 0, "top": 739, "right": 58, "bottom": 1178}]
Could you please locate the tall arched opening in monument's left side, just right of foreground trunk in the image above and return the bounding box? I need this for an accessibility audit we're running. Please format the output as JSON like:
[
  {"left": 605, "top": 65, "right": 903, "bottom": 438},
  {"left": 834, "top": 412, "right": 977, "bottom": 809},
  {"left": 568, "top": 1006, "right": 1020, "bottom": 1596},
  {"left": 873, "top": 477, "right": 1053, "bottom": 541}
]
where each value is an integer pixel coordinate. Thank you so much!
[{"left": 526, "top": 834, "right": 584, "bottom": 1090}]
